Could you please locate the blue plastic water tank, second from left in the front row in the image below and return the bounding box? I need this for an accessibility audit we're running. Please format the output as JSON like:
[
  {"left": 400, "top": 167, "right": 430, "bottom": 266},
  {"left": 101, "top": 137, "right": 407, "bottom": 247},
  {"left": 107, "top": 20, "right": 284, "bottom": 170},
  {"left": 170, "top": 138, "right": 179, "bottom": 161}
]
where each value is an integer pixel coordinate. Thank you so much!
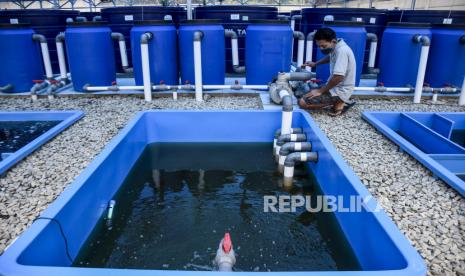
[{"left": 65, "top": 21, "right": 116, "bottom": 91}]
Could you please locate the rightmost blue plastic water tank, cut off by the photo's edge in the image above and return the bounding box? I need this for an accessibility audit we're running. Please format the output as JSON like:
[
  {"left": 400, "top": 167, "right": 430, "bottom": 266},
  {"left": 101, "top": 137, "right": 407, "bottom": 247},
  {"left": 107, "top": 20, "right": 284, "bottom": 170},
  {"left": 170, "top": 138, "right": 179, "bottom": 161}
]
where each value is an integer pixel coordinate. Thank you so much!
[{"left": 425, "top": 24, "right": 465, "bottom": 88}]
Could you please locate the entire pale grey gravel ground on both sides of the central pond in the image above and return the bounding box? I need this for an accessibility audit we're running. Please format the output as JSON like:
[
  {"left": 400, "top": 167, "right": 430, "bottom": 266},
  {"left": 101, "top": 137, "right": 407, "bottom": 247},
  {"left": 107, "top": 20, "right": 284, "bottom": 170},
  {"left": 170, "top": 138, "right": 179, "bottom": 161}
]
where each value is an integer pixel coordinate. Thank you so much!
[{"left": 0, "top": 94, "right": 465, "bottom": 275}]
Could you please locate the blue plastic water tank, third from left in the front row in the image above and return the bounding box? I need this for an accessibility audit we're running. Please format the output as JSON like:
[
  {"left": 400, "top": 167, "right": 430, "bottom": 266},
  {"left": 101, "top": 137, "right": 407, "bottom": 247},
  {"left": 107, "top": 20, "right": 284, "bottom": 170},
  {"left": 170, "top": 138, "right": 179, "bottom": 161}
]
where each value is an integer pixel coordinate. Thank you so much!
[{"left": 131, "top": 21, "right": 179, "bottom": 85}]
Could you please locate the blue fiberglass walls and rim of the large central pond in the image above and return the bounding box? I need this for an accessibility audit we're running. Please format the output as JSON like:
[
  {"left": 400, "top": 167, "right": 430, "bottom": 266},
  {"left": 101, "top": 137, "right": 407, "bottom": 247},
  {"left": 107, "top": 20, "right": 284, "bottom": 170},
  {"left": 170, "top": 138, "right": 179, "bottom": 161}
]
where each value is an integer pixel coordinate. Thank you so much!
[{"left": 0, "top": 111, "right": 426, "bottom": 275}]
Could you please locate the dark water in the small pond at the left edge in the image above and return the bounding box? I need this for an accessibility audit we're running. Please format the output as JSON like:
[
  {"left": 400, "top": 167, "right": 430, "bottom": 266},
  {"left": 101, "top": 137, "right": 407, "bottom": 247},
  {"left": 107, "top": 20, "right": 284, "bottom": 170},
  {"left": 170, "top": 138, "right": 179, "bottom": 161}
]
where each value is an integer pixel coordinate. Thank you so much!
[{"left": 0, "top": 121, "right": 61, "bottom": 161}]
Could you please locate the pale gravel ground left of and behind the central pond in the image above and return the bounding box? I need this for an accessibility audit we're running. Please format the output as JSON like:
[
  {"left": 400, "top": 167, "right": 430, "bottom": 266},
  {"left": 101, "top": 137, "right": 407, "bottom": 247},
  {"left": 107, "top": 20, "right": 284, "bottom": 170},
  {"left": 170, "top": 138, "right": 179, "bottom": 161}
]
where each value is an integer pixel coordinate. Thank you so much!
[{"left": 0, "top": 97, "right": 262, "bottom": 252}]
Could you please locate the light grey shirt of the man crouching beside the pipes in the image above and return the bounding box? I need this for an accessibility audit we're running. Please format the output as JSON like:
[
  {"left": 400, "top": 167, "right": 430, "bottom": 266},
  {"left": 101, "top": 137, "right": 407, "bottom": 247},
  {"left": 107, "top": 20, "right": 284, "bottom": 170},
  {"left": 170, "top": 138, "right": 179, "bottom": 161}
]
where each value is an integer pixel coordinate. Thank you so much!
[{"left": 329, "top": 39, "right": 356, "bottom": 102}]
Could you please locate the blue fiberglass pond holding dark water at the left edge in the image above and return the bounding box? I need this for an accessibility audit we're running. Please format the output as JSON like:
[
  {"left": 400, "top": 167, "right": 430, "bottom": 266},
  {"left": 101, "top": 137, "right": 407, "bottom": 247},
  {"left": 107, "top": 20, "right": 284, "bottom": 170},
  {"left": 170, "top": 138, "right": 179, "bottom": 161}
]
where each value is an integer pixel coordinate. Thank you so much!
[{"left": 0, "top": 111, "right": 84, "bottom": 175}]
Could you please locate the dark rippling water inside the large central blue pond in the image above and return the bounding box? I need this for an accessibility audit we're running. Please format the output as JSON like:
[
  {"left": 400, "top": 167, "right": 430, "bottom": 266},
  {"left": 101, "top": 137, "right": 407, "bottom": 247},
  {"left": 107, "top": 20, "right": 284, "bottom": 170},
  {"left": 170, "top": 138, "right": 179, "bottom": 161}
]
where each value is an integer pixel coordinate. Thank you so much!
[{"left": 74, "top": 143, "right": 360, "bottom": 271}]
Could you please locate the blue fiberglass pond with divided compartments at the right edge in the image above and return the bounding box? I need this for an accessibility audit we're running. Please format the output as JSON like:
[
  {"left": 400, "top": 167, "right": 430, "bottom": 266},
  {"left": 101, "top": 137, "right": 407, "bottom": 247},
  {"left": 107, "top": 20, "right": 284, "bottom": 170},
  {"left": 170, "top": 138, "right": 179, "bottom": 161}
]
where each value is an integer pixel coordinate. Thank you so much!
[{"left": 363, "top": 111, "right": 465, "bottom": 196}]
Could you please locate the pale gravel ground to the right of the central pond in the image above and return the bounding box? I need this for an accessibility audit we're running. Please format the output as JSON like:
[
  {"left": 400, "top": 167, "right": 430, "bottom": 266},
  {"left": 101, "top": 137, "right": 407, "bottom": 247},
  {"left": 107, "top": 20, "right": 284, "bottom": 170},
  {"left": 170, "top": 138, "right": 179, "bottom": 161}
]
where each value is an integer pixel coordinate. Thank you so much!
[{"left": 311, "top": 100, "right": 465, "bottom": 275}]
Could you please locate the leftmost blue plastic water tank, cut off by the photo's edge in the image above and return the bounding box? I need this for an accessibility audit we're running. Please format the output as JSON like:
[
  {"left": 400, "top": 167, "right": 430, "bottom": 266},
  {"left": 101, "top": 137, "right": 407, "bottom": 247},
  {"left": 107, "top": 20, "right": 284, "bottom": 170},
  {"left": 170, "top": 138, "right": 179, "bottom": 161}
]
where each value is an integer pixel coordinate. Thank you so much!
[{"left": 0, "top": 24, "right": 44, "bottom": 93}]
